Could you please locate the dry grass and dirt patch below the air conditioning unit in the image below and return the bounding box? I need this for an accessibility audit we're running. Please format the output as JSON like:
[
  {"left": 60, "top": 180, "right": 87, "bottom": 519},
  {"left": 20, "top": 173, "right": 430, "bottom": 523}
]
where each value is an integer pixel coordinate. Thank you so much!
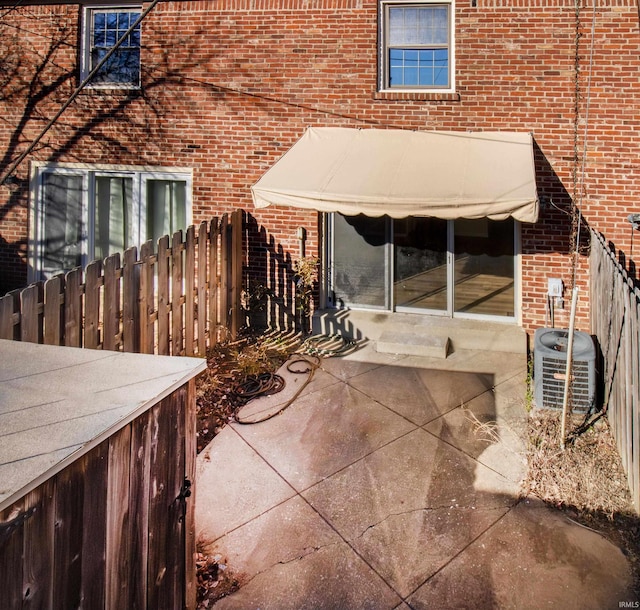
[{"left": 524, "top": 409, "right": 640, "bottom": 596}]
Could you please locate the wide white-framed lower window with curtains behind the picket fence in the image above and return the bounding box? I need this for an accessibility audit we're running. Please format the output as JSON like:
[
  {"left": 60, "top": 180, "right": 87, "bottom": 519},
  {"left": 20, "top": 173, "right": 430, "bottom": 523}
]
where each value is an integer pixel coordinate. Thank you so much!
[{"left": 30, "top": 165, "right": 192, "bottom": 280}]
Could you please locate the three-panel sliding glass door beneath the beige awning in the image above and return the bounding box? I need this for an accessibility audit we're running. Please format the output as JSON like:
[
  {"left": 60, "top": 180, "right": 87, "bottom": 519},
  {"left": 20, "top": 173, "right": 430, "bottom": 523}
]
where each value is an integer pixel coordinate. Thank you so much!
[{"left": 328, "top": 214, "right": 516, "bottom": 319}]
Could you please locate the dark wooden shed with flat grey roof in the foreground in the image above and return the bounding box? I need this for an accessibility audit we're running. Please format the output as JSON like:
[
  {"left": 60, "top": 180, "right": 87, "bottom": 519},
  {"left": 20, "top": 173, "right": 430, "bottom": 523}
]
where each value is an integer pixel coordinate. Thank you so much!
[{"left": 0, "top": 340, "right": 206, "bottom": 610}]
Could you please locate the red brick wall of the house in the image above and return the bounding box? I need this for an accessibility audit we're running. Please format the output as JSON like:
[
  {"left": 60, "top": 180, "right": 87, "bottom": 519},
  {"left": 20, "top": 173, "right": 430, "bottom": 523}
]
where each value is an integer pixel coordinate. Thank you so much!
[{"left": 0, "top": 0, "right": 640, "bottom": 331}]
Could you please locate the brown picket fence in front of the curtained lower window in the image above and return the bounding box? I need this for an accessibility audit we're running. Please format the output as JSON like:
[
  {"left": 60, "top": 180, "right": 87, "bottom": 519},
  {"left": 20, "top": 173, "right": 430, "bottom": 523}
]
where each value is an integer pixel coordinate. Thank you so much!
[{"left": 0, "top": 211, "right": 243, "bottom": 356}]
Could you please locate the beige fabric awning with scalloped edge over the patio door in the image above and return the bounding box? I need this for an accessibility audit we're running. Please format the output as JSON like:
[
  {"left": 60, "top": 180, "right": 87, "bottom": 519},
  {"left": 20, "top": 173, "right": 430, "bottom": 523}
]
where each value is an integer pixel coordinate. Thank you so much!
[{"left": 251, "top": 127, "right": 538, "bottom": 222}]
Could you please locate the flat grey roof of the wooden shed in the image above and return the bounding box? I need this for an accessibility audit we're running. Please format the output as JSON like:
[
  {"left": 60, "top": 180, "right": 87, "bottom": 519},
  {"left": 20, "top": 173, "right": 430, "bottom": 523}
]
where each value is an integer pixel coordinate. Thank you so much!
[{"left": 0, "top": 340, "right": 206, "bottom": 510}]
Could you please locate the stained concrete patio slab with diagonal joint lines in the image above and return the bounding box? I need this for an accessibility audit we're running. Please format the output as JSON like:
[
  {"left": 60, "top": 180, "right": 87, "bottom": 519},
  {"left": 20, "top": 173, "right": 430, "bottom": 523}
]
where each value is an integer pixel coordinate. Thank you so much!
[{"left": 196, "top": 344, "right": 635, "bottom": 610}]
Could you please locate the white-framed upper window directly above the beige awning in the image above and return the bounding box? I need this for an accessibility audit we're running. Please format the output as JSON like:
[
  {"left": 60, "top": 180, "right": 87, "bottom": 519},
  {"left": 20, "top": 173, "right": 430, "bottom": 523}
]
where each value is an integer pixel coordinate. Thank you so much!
[{"left": 380, "top": 1, "right": 454, "bottom": 91}]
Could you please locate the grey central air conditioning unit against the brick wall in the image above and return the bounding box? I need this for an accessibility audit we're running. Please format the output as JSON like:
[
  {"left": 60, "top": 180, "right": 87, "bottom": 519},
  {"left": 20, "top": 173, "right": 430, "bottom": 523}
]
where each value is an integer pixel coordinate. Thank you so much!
[{"left": 533, "top": 328, "right": 596, "bottom": 413}]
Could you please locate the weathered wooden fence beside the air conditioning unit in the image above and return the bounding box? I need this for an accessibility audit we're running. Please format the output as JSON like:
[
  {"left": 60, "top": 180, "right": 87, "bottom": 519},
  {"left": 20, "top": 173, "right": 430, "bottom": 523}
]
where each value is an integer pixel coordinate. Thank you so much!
[{"left": 590, "top": 231, "right": 640, "bottom": 510}]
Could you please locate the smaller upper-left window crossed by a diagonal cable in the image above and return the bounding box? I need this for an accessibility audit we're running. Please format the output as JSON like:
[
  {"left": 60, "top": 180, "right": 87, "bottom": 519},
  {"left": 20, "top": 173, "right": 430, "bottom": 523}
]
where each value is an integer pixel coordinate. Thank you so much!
[{"left": 82, "top": 6, "right": 141, "bottom": 88}]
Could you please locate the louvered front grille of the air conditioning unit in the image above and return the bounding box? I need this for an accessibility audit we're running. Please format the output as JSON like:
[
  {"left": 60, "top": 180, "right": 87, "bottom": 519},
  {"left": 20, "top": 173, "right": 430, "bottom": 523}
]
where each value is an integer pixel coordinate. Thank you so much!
[{"left": 542, "top": 357, "right": 593, "bottom": 410}]
